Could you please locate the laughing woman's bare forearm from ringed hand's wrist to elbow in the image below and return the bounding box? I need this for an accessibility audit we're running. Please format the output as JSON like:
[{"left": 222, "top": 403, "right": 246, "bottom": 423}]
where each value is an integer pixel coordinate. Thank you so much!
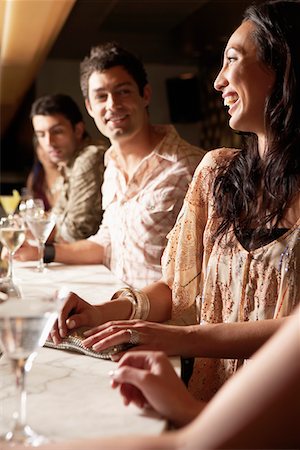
[{"left": 181, "top": 319, "right": 286, "bottom": 359}]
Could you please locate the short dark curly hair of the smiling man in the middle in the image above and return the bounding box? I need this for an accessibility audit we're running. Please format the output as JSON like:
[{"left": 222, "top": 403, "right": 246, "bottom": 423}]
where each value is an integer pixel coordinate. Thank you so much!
[{"left": 80, "top": 42, "right": 148, "bottom": 99}]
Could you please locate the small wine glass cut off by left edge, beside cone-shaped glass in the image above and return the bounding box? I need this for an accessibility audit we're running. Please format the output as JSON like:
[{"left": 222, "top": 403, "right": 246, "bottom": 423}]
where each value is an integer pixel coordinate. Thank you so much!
[{"left": 0, "top": 214, "right": 26, "bottom": 285}]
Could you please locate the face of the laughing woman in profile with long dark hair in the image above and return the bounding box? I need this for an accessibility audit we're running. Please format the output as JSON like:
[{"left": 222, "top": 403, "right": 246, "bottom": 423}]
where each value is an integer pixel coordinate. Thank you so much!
[{"left": 214, "top": 21, "right": 275, "bottom": 142}]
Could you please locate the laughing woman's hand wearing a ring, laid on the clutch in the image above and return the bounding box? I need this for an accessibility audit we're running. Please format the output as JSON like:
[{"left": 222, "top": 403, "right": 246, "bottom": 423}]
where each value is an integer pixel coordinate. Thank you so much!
[{"left": 83, "top": 320, "right": 189, "bottom": 361}]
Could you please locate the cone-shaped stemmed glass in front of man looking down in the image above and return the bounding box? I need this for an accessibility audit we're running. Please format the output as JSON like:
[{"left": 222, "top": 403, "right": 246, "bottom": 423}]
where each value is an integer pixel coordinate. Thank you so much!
[{"left": 26, "top": 210, "right": 55, "bottom": 272}]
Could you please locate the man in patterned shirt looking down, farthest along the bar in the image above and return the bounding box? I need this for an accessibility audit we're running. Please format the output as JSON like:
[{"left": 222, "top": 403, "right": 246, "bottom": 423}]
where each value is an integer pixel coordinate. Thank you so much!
[{"left": 30, "top": 94, "right": 104, "bottom": 242}]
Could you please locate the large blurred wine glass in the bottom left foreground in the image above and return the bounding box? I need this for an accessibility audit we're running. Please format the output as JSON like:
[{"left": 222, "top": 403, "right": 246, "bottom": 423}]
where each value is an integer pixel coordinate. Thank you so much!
[{"left": 0, "top": 294, "right": 60, "bottom": 447}]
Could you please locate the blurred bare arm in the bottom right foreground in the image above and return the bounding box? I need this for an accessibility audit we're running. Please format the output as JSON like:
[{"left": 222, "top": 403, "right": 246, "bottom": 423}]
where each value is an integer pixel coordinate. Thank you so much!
[{"left": 182, "top": 308, "right": 300, "bottom": 449}]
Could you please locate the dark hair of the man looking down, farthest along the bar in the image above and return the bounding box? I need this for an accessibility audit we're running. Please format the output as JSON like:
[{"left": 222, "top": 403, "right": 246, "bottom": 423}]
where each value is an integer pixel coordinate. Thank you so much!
[{"left": 30, "top": 94, "right": 83, "bottom": 127}]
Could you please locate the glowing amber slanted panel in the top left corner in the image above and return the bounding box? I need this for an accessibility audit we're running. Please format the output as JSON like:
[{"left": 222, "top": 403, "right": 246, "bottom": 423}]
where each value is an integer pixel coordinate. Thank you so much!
[{"left": 0, "top": 0, "right": 76, "bottom": 134}]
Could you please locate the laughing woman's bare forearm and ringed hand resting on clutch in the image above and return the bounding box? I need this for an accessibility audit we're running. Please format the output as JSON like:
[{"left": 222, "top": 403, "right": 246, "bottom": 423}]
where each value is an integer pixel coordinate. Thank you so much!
[{"left": 84, "top": 312, "right": 286, "bottom": 359}]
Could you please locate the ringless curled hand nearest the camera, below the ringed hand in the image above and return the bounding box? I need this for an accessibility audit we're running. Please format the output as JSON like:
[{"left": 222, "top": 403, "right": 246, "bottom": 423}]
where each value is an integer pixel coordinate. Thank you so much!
[{"left": 110, "top": 352, "right": 205, "bottom": 426}]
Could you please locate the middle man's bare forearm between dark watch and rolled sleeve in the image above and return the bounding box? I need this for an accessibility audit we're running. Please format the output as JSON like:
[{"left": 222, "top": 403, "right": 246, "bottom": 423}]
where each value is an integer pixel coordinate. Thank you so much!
[{"left": 54, "top": 239, "right": 103, "bottom": 264}]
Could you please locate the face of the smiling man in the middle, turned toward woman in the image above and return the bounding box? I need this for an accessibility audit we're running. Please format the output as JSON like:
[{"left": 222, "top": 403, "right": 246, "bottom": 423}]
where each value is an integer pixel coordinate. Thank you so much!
[{"left": 86, "top": 66, "right": 150, "bottom": 142}]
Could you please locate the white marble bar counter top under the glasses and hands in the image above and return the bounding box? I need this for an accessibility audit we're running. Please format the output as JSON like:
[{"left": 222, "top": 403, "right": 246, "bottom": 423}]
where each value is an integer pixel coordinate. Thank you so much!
[{"left": 0, "top": 263, "right": 179, "bottom": 441}]
